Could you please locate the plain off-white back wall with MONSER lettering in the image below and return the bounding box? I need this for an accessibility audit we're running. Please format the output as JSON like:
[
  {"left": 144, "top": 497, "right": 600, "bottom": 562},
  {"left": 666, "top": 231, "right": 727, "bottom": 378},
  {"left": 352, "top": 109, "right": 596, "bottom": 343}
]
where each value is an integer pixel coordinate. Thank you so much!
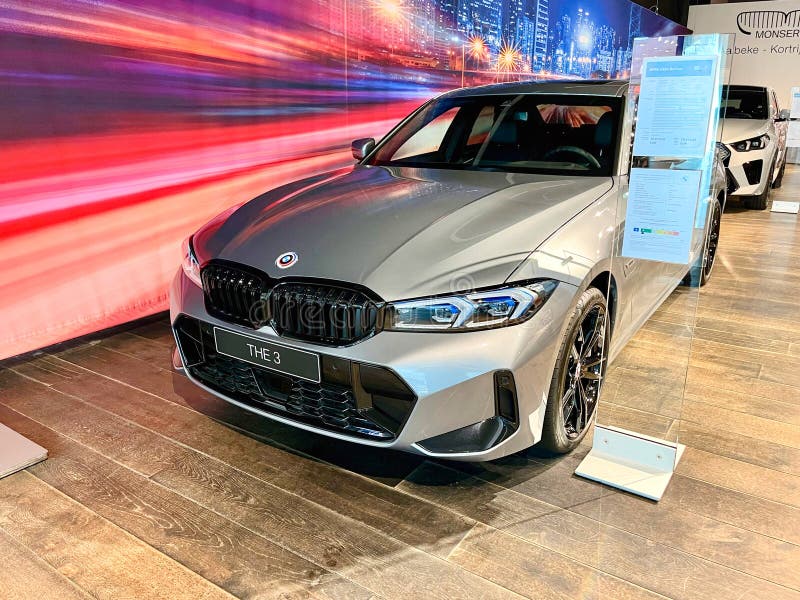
[{"left": 689, "top": 0, "right": 800, "bottom": 108}]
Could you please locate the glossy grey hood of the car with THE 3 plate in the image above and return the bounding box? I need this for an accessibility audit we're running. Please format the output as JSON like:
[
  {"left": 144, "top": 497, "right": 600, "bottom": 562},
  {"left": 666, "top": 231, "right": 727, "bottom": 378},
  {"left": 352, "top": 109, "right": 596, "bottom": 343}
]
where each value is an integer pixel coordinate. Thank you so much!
[{"left": 194, "top": 166, "right": 613, "bottom": 300}]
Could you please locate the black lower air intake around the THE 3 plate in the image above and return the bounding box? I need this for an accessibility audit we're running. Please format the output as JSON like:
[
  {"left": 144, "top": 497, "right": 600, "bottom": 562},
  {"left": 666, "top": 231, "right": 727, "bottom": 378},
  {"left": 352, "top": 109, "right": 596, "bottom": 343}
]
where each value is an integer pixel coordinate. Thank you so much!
[{"left": 174, "top": 315, "right": 416, "bottom": 441}]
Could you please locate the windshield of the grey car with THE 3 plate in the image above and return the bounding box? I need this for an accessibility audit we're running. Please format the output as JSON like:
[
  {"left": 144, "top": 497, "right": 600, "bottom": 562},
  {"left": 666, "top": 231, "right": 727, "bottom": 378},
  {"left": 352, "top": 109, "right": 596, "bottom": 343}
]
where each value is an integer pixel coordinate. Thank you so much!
[{"left": 366, "top": 94, "right": 622, "bottom": 175}]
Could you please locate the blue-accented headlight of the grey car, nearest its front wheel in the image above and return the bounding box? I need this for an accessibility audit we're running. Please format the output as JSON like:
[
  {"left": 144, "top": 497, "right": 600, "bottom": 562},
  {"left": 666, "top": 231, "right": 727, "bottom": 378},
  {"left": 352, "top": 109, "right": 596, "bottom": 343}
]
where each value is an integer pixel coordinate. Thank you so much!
[{"left": 384, "top": 280, "right": 557, "bottom": 331}]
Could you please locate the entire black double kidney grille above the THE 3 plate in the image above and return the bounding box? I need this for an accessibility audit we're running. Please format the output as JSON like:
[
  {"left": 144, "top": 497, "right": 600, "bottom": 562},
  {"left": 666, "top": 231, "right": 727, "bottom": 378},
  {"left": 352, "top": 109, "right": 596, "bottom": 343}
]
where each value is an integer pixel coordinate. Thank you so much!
[{"left": 201, "top": 261, "right": 382, "bottom": 346}]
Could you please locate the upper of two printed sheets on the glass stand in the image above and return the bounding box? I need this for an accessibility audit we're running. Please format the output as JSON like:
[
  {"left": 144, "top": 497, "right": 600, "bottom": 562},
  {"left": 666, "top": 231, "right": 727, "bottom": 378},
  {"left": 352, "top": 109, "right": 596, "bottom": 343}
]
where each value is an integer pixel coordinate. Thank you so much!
[{"left": 633, "top": 56, "right": 717, "bottom": 158}]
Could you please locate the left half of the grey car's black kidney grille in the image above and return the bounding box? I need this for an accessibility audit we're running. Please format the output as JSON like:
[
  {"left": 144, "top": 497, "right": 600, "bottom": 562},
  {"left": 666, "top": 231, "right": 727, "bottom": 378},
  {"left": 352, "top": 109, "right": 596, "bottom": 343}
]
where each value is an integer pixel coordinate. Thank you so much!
[{"left": 201, "top": 263, "right": 270, "bottom": 328}]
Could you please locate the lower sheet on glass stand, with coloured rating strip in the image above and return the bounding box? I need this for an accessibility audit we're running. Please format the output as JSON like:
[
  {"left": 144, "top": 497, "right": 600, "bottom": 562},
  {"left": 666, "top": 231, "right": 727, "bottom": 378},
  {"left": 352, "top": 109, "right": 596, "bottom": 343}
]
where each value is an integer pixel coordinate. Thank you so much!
[{"left": 622, "top": 168, "right": 703, "bottom": 264}]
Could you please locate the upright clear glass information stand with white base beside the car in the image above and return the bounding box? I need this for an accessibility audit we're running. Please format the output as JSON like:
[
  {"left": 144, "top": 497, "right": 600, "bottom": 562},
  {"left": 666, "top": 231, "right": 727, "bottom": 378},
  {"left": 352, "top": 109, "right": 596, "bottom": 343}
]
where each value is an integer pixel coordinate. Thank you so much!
[{"left": 575, "top": 34, "right": 732, "bottom": 501}]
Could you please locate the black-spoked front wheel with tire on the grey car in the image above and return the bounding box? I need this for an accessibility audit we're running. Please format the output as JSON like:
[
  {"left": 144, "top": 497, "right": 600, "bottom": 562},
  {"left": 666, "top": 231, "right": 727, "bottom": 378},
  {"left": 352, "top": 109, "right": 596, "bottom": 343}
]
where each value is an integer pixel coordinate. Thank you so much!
[{"left": 537, "top": 287, "right": 611, "bottom": 454}]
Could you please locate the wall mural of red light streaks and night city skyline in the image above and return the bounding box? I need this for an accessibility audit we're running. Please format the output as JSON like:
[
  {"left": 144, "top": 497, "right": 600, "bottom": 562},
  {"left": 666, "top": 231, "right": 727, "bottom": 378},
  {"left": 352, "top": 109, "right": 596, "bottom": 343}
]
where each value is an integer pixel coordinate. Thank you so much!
[{"left": 0, "top": 0, "right": 685, "bottom": 358}]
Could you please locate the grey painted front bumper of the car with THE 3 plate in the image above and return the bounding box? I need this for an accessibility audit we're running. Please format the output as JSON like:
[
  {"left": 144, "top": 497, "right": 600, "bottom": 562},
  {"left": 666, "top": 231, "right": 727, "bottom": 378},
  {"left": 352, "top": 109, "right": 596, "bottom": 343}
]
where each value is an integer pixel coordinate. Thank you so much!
[{"left": 170, "top": 271, "right": 577, "bottom": 461}]
